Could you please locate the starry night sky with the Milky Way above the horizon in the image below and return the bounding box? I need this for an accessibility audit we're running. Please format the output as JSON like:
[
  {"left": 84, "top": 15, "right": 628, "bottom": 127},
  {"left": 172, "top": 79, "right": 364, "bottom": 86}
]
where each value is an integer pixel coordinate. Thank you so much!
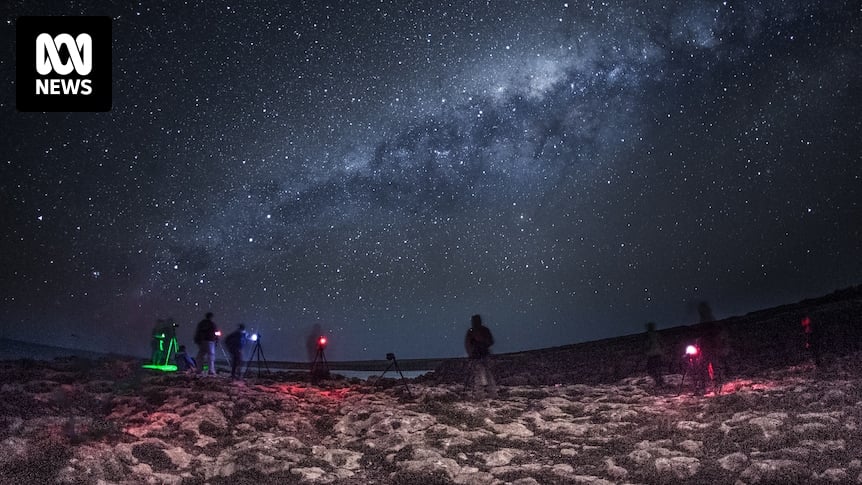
[{"left": 0, "top": 0, "right": 862, "bottom": 360}]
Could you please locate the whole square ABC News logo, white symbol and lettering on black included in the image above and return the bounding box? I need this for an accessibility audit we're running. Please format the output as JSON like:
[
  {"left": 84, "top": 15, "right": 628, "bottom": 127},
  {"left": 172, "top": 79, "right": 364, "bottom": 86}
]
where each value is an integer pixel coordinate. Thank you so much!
[{"left": 16, "top": 17, "right": 111, "bottom": 111}]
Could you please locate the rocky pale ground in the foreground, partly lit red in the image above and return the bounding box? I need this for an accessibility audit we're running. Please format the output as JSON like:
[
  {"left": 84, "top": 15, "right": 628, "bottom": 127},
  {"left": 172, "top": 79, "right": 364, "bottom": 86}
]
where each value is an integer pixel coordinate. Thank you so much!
[{"left": 0, "top": 353, "right": 862, "bottom": 484}]
